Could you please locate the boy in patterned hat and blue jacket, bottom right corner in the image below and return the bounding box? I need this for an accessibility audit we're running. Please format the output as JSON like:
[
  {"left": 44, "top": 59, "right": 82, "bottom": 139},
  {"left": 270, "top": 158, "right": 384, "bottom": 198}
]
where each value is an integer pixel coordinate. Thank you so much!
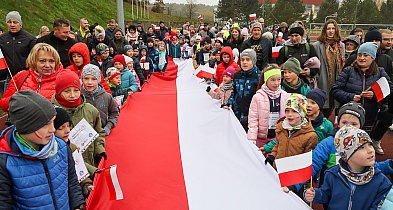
[{"left": 305, "top": 125, "right": 392, "bottom": 210}]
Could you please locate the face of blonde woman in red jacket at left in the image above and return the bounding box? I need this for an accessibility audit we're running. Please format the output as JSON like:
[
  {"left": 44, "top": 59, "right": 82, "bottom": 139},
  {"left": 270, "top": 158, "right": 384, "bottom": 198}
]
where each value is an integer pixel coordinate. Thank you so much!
[{"left": 35, "top": 50, "right": 56, "bottom": 77}]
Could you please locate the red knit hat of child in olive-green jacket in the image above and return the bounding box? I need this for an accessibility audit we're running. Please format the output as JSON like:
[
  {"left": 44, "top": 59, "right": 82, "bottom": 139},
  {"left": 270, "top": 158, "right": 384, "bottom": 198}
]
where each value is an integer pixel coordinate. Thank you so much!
[{"left": 55, "top": 69, "right": 81, "bottom": 95}]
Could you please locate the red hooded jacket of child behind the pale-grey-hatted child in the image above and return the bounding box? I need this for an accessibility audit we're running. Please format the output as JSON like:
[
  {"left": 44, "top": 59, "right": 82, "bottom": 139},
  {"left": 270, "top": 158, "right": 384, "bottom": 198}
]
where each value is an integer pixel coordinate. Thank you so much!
[{"left": 67, "top": 42, "right": 112, "bottom": 94}]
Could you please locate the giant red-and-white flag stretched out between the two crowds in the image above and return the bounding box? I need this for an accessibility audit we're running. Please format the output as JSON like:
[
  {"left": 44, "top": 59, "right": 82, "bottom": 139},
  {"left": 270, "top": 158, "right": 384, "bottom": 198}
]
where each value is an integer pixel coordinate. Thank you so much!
[{"left": 88, "top": 60, "right": 309, "bottom": 210}]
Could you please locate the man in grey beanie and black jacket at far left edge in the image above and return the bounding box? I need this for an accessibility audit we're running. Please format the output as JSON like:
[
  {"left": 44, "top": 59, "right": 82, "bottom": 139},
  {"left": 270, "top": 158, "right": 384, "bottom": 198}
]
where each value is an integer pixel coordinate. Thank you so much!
[{"left": 0, "top": 11, "right": 36, "bottom": 92}]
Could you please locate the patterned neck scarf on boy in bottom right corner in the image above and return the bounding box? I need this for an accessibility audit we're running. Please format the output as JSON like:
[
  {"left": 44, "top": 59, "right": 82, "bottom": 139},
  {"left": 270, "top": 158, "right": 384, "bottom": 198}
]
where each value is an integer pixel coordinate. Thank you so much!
[{"left": 339, "top": 159, "right": 374, "bottom": 185}]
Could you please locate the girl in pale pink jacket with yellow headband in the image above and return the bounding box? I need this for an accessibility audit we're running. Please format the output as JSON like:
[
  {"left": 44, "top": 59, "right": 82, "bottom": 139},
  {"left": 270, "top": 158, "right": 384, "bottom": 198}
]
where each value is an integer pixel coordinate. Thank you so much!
[{"left": 247, "top": 67, "right": 290, "bottom": 148}]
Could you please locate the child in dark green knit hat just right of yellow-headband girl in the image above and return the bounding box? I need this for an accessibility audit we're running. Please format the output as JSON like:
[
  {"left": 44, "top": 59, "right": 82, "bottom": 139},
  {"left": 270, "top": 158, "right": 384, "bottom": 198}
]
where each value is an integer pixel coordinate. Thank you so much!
[{"left": 281, "top": 57, "right": 310, "bottom": 96}]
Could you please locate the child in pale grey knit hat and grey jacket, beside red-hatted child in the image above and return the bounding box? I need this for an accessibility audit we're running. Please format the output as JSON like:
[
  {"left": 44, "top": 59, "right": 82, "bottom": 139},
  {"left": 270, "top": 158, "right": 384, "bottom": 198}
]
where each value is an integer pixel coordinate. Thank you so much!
[{"left": 82, "top": 64, "right": 119, "bottom": 135}]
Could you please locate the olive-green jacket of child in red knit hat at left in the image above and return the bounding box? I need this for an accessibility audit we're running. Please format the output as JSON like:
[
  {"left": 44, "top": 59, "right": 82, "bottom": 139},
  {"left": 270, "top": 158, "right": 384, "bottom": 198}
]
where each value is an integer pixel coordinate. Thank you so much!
[{"left": 52, "top": 95, "right": 105, "bottom": 176}]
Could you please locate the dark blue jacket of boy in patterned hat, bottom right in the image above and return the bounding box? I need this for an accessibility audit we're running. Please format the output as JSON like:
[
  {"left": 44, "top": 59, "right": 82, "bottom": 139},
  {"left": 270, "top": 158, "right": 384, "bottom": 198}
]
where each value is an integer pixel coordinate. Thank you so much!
[{"left": 313, "top": 165, "right": 392, "bottom": 210}]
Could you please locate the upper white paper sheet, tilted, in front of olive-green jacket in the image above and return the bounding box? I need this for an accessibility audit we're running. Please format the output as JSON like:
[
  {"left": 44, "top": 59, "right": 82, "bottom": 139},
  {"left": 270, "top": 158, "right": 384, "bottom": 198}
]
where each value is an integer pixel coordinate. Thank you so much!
[{"left": 69, "top": 118, "right": 98, "bottom": 153}]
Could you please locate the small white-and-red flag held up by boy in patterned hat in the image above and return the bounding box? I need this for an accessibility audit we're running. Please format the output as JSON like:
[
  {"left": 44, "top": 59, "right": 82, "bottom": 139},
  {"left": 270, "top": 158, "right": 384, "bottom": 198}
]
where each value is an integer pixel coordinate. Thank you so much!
[{"left": 275, "top": 151, "right": 312, "bottom": 187}]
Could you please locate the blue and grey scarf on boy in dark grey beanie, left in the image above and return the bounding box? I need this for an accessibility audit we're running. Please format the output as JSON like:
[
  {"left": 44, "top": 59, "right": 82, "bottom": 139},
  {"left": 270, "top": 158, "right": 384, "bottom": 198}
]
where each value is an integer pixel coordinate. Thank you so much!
[{"left": 12, "top": 130, "right": 58, "bottom": 159}]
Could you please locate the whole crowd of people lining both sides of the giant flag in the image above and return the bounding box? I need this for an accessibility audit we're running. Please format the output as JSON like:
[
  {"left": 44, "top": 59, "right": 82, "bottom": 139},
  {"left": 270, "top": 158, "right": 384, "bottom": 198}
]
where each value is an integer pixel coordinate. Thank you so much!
[{"left": 0, "top": 11, "right": 393, "bottom": 209}]
